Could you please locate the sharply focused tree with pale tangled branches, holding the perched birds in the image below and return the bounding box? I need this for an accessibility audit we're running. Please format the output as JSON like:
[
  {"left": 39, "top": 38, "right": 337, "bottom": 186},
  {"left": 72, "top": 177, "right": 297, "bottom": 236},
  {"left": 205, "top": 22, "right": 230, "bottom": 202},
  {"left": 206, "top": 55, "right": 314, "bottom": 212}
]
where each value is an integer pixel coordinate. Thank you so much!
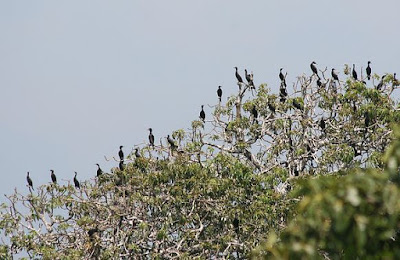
[{"left": 0, "top": 63, "right": 400, "bottom": 259}]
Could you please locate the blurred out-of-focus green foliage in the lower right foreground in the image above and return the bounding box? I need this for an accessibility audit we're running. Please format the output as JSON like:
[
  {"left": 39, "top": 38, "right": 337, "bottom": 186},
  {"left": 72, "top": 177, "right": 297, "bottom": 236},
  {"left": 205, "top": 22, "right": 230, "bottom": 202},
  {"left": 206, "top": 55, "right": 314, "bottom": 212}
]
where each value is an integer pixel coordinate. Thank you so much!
[{"left": 253, "top": 127, "right": 400, "bottom": 259}]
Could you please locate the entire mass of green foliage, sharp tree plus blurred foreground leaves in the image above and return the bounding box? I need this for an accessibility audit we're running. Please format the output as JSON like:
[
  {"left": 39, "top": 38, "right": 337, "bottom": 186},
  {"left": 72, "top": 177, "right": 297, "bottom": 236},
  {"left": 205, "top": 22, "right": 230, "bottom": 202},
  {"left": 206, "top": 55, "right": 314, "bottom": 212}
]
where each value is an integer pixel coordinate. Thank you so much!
[{"left": 0, "top": 65, "right": 400, "bottom": 259}]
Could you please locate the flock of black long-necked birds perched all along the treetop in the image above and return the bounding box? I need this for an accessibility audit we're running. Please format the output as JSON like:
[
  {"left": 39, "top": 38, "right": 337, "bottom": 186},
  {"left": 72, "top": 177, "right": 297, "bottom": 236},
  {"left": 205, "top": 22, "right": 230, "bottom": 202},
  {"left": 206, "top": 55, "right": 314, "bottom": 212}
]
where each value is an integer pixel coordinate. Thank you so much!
[{"left": 26, "top": 61, "right": 397, "bottom": 193}]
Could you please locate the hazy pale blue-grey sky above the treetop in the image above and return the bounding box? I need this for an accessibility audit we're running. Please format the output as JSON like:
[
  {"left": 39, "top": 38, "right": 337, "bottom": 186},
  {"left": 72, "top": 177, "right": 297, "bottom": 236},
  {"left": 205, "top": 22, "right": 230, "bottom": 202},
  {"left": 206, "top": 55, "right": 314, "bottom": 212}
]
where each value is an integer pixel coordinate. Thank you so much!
[{"left": 0, "top": 0, "right": 400, "bottom": 201}]
